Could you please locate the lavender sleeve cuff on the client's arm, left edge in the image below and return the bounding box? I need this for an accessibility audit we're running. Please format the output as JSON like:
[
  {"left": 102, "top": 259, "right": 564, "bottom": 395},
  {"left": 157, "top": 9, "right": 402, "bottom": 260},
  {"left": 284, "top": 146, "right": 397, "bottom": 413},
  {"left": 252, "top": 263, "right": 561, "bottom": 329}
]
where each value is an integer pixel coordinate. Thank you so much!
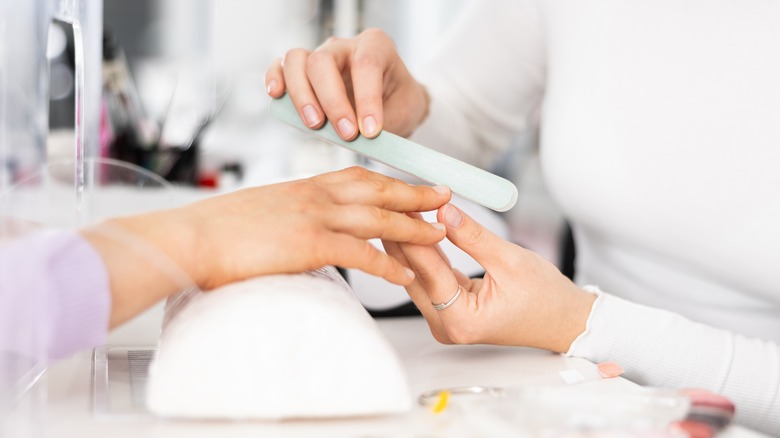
[{"left": 0, "top": 230, "right": 111, "bottom": 360}]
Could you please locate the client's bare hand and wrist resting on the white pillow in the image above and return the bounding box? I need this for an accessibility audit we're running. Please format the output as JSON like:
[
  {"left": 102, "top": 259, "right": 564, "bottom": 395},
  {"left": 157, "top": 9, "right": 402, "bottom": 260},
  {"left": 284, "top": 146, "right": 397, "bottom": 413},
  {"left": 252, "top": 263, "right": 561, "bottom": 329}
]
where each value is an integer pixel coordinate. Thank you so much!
[{"left": 82, "top": 167, "right": 451, "bottom": 326}]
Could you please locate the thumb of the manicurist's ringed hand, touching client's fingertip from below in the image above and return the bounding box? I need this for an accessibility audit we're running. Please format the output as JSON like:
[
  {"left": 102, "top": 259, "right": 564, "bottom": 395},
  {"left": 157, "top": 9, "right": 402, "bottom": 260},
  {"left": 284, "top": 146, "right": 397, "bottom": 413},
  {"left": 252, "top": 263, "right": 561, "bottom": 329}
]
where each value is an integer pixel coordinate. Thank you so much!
[{"left": 437, "top": 204, "right": 506, "bottom": 271}]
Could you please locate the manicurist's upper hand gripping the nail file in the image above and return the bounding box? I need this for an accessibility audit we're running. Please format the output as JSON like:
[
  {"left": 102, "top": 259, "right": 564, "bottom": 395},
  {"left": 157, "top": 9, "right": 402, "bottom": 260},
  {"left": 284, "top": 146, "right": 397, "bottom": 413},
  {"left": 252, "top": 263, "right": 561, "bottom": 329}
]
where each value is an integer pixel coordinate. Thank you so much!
[{"left": 265, "top": 29, "right": 428, "bottom": 140}]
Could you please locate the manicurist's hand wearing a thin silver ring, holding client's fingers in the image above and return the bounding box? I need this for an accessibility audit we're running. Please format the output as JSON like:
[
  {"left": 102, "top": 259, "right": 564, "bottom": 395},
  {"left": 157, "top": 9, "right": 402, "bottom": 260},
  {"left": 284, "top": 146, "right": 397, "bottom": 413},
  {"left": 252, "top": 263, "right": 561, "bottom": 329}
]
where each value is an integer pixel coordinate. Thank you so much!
[{"left": 383, "top": 204, "right": 595, "bottom": 352}]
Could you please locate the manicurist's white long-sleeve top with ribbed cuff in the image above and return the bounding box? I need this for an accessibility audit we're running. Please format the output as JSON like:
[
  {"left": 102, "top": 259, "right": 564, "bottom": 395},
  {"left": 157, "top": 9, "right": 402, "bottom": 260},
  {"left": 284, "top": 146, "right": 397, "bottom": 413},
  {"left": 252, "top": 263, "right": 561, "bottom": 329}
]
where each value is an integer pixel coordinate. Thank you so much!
[{"left": 413, "top": 0, "right": 780, "bottom": 434}]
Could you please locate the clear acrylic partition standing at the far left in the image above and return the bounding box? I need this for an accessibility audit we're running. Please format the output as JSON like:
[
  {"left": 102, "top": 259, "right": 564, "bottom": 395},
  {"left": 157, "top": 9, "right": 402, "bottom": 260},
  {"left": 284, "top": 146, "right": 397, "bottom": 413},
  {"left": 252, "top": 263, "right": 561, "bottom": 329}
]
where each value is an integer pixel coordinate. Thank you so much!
[{"left": 0, "top": 0, "right": 103, "bottom": 436}]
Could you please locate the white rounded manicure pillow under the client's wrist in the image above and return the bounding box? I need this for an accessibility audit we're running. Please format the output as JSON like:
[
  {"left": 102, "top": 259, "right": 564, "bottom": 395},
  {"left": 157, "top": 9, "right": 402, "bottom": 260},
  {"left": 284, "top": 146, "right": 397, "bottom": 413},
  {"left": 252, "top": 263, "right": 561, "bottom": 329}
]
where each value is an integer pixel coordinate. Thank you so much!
[{"left": 147, "top": 268, "right": 412, "bottom": 419}]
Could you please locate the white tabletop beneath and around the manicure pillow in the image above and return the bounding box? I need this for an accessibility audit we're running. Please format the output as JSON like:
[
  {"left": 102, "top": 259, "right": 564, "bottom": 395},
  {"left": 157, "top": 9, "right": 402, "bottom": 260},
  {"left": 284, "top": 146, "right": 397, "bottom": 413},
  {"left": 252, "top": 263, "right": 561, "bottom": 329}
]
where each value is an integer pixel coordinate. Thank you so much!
[{"left": 6, "top": 306, "right": 759, "bottom": 438}]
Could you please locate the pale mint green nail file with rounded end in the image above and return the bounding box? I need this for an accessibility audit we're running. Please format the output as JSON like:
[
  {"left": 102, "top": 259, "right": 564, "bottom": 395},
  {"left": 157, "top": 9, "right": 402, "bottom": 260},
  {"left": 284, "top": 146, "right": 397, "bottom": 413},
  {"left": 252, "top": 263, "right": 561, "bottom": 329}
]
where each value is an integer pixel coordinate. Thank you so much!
[{"left": 270, "top": 94, "right": 517, "bottom": 211}]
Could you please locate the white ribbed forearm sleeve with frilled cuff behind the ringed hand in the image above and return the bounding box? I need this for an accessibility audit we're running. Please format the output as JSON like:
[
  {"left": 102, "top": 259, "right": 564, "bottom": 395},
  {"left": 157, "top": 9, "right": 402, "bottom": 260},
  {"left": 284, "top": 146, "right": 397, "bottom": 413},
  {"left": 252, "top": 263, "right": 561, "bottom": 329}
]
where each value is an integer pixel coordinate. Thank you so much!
[{"left": 568, "top": 294, "right": 780, "bottom": 433}]
